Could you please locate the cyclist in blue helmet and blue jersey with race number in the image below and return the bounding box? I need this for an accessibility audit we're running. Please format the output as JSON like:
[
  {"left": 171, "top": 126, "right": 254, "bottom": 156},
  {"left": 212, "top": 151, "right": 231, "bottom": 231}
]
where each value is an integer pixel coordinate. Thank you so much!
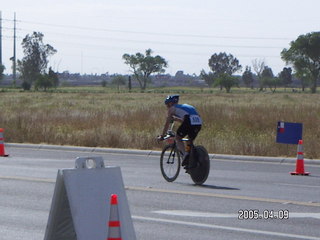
[{"left": 160, "top": 95, "right": 202, "bottom": 166}]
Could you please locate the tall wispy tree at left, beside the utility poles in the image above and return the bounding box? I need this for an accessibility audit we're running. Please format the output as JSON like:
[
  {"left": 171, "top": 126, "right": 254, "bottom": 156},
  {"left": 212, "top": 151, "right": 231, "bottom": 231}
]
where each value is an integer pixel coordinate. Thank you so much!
[{"left": 18, "top": 32, "right": 57, "bottom": 89}]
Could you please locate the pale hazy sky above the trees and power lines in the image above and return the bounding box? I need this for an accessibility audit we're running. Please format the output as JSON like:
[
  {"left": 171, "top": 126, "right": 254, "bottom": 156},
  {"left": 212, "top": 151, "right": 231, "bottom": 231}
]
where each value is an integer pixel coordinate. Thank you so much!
[{"left": 0, "top": 0, "right": 320, "bottom": 75}]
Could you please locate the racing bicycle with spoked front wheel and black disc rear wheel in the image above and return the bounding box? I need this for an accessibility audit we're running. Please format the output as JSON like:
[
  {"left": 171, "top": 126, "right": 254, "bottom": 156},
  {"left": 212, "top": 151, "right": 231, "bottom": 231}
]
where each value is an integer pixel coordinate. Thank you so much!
[{"left": 160, "top": 127, "right": 210, "bottom": 185}]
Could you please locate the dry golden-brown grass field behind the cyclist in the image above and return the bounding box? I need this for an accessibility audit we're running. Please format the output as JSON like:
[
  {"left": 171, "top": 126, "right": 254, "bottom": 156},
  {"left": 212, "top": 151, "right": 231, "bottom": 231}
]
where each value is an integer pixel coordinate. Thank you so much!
[{"left": 0, "top": 91, "right": 320, "bottom": 158}]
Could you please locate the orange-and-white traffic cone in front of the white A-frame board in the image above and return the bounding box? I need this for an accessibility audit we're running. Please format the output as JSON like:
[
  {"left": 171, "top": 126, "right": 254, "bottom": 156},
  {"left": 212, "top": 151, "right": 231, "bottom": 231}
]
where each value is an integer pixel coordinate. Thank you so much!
[{"left": 107, "top": 194, "right": 122, "bottom": 240}]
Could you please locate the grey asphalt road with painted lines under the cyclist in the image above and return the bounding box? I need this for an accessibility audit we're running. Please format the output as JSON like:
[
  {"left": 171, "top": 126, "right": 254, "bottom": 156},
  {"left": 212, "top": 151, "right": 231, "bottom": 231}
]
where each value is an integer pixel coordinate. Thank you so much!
[{"left": 0, "top": 147, "right": 320, "bottom": 240}]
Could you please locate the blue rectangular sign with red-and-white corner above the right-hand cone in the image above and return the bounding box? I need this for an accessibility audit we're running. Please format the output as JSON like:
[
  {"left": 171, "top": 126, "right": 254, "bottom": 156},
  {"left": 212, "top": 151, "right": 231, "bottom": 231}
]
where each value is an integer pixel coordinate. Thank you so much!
[{"left": 276, "top": 122, "right": 303, "bottom": 144}]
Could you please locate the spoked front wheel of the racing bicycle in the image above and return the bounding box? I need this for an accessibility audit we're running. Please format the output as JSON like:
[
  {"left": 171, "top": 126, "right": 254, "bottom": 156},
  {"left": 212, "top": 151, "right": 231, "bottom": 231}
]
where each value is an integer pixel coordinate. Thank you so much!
[{"left": 160, "top": 144, "right": 181, "bottom": 182}]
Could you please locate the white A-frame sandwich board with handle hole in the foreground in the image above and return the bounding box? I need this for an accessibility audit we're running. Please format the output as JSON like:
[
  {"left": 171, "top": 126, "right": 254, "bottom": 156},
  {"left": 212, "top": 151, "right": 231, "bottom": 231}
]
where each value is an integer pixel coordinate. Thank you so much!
[{"left": 44, "top": 157, "right": 136, "bottom": 240}]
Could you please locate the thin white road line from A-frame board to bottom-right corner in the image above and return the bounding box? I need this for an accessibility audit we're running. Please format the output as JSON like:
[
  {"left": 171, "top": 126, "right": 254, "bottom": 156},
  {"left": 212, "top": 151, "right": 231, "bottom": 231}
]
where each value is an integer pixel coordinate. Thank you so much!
[{"left": 132, "top": 216, "right": 320, "bottom": 240}]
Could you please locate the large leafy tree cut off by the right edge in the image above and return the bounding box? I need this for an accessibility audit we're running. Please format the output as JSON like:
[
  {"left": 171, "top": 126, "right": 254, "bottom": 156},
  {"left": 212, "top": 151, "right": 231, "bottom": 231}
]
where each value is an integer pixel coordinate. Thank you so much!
[{"left": 281, "top": 32, "right": 320, "bottom": 93}]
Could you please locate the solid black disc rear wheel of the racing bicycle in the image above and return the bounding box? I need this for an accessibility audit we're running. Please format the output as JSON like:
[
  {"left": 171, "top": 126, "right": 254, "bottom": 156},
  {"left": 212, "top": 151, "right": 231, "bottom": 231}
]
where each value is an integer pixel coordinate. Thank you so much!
[{"left": 190, "top": 146, "right": 210, "bottom": 185}]
